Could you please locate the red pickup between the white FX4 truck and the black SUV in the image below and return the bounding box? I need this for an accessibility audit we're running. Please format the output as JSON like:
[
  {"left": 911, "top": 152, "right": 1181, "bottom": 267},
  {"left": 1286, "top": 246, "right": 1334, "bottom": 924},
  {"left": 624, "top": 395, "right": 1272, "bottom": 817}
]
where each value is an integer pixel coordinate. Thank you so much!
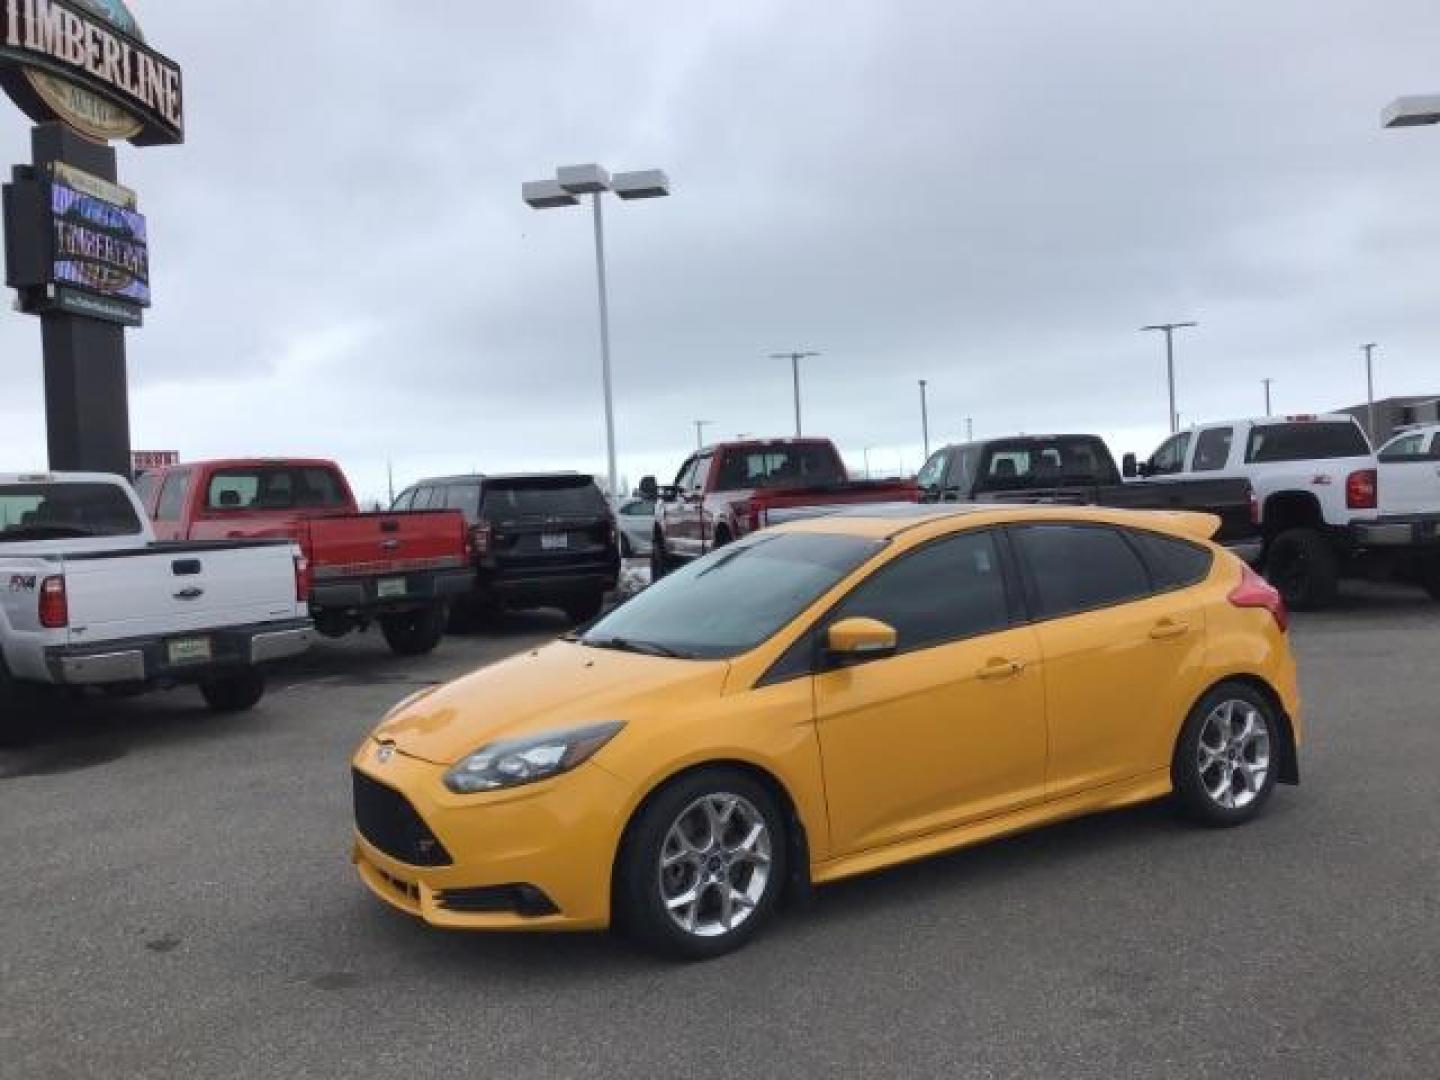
[{"left": 135, "top": 458, "right": 475, "bottom": 657}]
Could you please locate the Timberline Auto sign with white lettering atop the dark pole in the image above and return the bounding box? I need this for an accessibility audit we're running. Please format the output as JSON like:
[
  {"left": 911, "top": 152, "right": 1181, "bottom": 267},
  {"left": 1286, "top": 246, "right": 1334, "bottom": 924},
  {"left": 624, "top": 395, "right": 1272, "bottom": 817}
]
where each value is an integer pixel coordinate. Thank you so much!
[{"left": 0, "top": 0, "right": 184, "bottom": 145}]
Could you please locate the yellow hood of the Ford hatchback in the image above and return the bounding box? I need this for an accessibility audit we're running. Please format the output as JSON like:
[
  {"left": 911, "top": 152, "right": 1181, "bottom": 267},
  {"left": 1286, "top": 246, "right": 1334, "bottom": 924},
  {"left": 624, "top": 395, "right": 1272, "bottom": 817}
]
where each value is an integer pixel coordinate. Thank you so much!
[{"left": 374, "top": 641, "right": 729, "bottom": 765}]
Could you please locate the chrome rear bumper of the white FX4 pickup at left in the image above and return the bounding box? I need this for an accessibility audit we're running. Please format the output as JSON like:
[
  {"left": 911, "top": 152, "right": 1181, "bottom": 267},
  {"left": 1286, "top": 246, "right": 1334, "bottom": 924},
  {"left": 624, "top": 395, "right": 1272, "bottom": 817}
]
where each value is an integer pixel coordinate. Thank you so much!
[{"left": 45, "top": 619, "right": 314, "bottom": 687}]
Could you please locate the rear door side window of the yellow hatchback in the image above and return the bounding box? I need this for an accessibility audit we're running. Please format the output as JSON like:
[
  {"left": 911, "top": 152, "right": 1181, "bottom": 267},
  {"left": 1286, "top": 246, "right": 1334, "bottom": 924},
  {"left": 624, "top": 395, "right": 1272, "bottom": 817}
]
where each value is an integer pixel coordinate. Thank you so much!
[{"left": 1012, "top": 524, "right": 1153, "bottom": 619}]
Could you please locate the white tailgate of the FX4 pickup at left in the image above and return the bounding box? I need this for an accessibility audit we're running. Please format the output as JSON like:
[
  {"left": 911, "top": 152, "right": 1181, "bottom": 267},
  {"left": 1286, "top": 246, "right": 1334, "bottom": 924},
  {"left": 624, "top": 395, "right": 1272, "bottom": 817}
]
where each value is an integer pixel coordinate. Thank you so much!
[{"left": 63, "top": 543, "right": 304, "bottom": 644}]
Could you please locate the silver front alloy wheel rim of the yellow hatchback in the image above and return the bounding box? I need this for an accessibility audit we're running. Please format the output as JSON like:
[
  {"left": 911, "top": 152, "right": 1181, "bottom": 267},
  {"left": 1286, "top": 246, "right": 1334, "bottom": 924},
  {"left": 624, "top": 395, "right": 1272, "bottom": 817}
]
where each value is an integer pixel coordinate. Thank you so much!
[{"left": 658, "top": 792, "right": 770, "bottom": 937}]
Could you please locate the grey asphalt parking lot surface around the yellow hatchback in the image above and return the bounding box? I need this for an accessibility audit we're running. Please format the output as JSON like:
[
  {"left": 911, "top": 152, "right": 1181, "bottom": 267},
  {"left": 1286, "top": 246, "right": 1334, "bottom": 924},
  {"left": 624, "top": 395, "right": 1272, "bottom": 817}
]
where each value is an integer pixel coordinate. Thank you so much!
[{"left": 0, "top": 588, "right": 1440, "bottom": 1080}]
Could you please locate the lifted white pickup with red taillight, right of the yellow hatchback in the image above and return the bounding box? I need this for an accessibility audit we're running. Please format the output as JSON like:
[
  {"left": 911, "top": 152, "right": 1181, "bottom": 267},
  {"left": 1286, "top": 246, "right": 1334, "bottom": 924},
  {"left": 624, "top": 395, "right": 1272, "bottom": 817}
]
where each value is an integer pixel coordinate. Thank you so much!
[{"left": 1128, "top": 413, "right": 1440, "bottom": 611}]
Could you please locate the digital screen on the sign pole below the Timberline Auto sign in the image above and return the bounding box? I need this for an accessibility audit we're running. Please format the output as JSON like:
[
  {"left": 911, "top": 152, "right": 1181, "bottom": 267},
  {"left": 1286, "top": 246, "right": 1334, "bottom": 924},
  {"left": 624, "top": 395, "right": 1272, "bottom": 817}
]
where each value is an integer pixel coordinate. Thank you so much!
[{"left": 50, "top": 180, "right": 150, "bottom": 307}]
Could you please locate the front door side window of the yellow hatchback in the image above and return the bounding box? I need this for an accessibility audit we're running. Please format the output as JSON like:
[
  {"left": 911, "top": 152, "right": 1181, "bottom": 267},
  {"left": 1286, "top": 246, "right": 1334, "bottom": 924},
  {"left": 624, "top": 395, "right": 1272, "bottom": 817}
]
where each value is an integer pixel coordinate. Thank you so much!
[{"left": 827, "top": 530, "right": 1011, "bottom": 652}]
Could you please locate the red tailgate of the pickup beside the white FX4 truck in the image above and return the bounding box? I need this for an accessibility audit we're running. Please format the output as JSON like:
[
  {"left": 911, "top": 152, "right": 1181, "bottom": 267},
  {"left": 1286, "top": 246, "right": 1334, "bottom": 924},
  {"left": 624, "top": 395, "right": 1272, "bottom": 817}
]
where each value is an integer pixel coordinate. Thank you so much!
[{"left": 301, "top": 510, "right": 467, "bottom": 580}]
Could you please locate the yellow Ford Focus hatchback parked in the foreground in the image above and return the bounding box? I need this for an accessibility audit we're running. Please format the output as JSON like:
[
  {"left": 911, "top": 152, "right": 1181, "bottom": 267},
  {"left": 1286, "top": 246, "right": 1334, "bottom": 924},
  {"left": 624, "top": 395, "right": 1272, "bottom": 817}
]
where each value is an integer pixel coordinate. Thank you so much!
[{"left": 353, "top": 507, "right": 1300, "bottom": 958}]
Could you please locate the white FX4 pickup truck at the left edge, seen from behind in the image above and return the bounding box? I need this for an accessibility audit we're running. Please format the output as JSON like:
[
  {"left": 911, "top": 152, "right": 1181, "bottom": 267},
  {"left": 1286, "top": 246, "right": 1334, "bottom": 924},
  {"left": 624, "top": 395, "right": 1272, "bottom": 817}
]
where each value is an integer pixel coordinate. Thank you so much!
[{"left": 0, "top": 472, "right": 312, "bottom": 733}]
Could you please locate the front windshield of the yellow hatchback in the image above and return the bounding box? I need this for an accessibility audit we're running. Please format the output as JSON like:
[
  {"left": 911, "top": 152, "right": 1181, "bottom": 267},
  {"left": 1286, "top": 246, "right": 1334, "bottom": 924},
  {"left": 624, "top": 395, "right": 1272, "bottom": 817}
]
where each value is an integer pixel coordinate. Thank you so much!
[{"left": 579, "top": 533, "right": 881, "bottom": 660}]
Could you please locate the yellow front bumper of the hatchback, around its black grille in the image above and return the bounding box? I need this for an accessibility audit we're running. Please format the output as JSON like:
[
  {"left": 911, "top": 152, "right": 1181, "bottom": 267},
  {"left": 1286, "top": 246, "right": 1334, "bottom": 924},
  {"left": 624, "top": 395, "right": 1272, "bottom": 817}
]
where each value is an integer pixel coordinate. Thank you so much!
[{"left": 351, "top": 740, "right": 628, "bottom": 930}]
